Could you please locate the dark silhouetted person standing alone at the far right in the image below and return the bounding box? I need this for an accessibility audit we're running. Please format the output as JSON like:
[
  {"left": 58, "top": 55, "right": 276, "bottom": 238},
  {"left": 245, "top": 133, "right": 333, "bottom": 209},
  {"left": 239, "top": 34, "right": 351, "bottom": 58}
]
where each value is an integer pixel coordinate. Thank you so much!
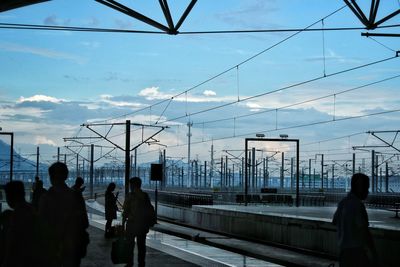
[{"left": 333, "top": 173, "right": 379, "bottom": 267}]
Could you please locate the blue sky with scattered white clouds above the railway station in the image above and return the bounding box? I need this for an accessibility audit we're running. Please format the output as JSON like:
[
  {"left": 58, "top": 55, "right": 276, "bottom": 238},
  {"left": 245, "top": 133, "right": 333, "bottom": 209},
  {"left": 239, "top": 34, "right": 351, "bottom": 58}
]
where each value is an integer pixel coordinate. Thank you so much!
[{"left": 0, "top": 0, "right": 400, "bottom": 175}]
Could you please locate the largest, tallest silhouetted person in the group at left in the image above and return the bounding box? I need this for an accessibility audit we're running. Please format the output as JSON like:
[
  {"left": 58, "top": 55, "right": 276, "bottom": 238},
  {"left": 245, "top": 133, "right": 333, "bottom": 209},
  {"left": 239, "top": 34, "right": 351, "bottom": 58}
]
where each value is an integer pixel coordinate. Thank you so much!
[{"left": 39, "top": 162, "right": 89, "bottom": 267}]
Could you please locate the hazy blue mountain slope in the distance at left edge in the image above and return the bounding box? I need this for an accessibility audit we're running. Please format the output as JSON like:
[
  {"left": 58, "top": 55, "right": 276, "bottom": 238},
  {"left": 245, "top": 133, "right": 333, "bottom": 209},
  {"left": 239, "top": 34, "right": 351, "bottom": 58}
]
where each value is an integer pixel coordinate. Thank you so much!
[{"left": 0, "top": 140, "right": 47, "bottom": 171}]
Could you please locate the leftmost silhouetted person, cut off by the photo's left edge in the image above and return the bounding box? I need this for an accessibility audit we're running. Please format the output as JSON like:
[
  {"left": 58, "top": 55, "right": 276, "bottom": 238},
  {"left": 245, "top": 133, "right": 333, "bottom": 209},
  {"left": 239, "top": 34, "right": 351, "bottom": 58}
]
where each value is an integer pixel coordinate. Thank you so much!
[{"left": 2, "top": 181, "right": 40, "bottom": 267}]
